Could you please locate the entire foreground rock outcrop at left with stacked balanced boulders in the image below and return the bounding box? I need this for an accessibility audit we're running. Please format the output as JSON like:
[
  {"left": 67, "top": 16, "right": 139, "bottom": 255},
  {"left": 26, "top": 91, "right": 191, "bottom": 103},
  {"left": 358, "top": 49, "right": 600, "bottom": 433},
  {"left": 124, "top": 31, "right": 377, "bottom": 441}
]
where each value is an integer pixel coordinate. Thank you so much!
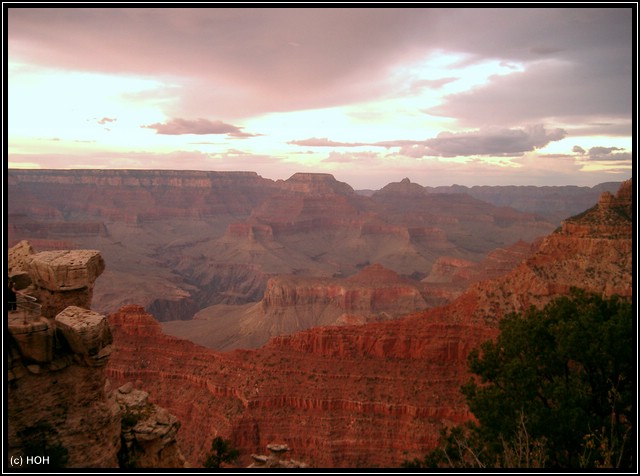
[{"left": 6, "top": 243, "right": 184, "bottom": 469}]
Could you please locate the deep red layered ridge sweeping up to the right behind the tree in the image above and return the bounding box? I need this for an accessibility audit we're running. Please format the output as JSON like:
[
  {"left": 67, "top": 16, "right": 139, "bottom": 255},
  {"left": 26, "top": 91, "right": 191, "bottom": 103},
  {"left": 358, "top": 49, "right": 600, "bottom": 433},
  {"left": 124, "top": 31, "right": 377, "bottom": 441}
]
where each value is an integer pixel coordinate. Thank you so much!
[{"left": 102, "top": 181, "right": 633, "bottom": 468}]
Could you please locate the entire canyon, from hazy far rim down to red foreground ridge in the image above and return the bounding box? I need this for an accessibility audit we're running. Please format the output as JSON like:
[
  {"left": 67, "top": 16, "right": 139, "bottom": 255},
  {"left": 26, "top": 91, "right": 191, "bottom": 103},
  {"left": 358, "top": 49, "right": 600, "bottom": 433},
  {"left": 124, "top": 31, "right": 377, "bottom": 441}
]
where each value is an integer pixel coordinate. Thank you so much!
[{"left": 9, "top": 171, "right": 633, "bottom": 468}]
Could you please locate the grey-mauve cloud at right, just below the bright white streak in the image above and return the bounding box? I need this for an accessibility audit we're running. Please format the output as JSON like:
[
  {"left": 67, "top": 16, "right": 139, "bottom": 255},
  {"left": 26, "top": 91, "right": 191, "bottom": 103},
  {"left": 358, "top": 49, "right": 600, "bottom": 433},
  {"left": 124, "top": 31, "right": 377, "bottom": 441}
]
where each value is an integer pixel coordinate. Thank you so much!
[{"left": 425, "top": 59, "right": 633, "bottom": 127}]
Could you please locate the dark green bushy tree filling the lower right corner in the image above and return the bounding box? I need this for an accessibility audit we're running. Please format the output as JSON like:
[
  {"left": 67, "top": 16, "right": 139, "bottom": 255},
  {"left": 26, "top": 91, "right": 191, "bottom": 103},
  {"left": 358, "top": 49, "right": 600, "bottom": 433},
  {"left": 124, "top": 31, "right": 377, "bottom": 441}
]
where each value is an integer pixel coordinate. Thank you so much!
[{"left": 405, "top": 290, "right": 635, "bottom": 468}]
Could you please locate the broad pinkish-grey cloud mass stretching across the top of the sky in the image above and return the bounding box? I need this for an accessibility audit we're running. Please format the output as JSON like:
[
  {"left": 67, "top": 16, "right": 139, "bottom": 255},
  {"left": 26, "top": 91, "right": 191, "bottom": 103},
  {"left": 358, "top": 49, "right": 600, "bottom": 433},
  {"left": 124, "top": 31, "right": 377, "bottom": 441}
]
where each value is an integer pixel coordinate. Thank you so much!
[{"left": 7, "top": 7, "right": 634, "bottom": 121}]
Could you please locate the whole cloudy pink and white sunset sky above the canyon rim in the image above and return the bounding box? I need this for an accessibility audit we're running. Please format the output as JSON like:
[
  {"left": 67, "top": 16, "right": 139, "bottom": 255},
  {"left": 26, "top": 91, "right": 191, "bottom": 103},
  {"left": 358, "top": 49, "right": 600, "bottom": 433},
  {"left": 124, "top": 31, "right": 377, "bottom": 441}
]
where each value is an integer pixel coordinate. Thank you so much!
[{"left": 3, "top": 3, "right": 637, "bottom": 189}]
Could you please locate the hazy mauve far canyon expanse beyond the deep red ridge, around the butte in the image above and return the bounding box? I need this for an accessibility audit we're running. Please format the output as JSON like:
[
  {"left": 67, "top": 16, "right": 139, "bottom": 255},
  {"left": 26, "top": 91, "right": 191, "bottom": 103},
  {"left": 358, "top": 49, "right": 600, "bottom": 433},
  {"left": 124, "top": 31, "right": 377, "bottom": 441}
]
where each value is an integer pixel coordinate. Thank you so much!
[{"left": 7, "top": 170, "right": 615, "bottom": 350}]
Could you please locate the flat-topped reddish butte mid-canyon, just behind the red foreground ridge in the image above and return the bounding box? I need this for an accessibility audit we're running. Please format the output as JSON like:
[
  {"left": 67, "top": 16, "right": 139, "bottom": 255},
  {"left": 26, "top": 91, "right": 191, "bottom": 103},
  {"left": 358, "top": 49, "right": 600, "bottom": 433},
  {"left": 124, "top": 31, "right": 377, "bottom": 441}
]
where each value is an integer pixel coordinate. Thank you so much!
[{"left": 161, "top": 264, "right": 428, "bottom": 350}]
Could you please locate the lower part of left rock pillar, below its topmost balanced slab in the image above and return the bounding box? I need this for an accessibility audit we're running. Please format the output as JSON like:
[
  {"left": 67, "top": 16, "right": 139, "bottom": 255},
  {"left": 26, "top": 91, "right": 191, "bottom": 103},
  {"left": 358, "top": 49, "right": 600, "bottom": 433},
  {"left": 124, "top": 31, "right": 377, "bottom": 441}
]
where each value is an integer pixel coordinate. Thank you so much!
[{"left": 7, "top": 308, "right": 121, "bottom": 468}]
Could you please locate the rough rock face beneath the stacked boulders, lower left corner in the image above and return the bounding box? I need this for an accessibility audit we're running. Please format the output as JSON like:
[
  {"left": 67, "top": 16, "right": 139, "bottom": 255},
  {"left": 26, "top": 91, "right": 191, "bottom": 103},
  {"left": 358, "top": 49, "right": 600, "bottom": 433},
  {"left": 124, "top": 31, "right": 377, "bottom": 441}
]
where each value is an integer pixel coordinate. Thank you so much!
[{"left": 7, "top": 334, "right": 121, "bottom": 468}]
